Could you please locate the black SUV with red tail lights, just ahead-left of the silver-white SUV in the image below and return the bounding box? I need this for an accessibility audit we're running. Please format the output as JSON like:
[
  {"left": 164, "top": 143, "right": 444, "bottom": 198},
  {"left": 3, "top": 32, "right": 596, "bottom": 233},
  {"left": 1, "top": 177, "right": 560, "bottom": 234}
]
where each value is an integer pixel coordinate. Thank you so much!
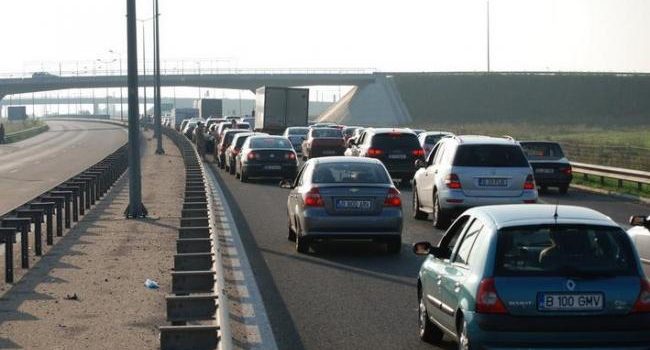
[{"left": 345, "top": 128, "right": 424, "bottom": 184}]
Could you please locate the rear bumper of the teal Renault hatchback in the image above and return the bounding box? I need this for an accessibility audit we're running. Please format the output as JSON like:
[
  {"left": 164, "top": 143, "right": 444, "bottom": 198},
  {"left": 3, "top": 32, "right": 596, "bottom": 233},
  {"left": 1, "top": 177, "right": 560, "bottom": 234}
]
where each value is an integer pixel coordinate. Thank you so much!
[{"left": 464, "top": 312, "right": 650, "bottom": 349}]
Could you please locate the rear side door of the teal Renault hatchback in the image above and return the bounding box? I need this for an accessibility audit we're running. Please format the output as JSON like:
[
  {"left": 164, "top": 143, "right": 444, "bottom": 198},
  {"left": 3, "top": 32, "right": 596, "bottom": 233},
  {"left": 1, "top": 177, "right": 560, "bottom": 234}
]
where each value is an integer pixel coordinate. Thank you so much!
[{"left": 440, "top": 219, "right": 484, "bottom": 329}]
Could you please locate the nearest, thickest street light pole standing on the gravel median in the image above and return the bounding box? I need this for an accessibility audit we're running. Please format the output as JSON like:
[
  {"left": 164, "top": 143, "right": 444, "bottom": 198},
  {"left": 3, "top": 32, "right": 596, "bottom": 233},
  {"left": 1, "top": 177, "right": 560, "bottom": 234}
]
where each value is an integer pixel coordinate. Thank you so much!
[{"left": 124, "top": 0, "right": 147, "bottom": 219}]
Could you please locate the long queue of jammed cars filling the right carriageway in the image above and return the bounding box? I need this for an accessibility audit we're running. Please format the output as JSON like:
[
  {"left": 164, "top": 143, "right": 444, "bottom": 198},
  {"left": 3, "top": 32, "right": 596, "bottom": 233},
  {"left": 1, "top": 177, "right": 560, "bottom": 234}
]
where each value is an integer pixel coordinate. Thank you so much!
[{"left": 168, "top": 88, "right": 650, "bottom": 349}]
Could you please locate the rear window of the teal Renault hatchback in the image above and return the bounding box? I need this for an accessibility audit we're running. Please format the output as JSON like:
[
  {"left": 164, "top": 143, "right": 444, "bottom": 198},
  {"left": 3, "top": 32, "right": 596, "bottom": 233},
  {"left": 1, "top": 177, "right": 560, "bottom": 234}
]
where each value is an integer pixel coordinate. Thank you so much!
[{"left": 495, "top": 224, "right": 638, "bottom": 277}]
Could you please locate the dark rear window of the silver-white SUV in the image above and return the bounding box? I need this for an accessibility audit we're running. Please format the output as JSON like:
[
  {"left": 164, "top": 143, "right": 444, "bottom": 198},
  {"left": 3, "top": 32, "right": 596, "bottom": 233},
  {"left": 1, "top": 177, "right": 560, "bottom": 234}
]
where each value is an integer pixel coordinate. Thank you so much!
[{"left": 454, "top": 144, "right": 530, "bottom": 168}]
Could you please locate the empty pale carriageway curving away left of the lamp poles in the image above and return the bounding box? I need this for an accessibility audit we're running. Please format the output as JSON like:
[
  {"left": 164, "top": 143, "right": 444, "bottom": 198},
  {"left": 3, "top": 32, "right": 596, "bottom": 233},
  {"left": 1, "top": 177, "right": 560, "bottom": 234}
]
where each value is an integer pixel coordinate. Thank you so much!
[{"left": 0, "top": 121, "right": 127, "bottom": 215}]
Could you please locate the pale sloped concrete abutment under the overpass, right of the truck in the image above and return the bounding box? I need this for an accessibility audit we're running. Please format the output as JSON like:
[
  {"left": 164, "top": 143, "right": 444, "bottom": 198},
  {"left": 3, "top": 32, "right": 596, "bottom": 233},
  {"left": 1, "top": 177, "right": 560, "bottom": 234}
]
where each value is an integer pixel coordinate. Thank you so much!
[{"left": 318, "top": 74, "right": 412, "bottom": 127}]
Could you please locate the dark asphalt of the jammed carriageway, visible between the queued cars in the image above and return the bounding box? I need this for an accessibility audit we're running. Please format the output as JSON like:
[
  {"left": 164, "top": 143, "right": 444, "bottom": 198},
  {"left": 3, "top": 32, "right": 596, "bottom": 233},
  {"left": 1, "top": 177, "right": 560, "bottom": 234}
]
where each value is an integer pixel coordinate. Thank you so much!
[{"left": 210, "top": 165, "right": 649, "bottom": 349}]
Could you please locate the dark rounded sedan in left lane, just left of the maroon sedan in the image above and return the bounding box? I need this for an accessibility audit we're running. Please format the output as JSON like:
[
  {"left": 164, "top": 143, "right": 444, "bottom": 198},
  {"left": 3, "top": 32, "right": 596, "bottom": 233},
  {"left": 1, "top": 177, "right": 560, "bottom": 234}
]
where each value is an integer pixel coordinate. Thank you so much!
[{"left": 235, "top": 135, "right": 298, "bottom": 182}]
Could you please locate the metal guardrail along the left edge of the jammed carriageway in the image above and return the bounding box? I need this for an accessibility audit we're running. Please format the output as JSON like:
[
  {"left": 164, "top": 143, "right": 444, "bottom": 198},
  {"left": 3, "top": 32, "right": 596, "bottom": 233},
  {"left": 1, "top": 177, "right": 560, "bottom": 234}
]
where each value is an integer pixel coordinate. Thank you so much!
[{"left": 159, "top": 128, "right": 232, "bottom": 350}]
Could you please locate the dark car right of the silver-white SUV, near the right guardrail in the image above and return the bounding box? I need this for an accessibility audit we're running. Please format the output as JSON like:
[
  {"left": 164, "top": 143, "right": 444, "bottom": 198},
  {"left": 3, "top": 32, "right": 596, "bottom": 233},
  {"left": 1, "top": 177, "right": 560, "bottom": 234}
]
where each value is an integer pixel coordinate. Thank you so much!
[{"left": 519, "top": 141, "right": 573, "bottom": 194}]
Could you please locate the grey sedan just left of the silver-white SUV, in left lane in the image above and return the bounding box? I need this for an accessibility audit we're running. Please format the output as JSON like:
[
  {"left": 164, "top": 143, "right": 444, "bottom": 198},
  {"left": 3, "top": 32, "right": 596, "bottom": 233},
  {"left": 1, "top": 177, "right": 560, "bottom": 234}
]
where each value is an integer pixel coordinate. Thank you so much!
[{"left": 283, "top": 156, "right": 403, "bottom": 254}]
